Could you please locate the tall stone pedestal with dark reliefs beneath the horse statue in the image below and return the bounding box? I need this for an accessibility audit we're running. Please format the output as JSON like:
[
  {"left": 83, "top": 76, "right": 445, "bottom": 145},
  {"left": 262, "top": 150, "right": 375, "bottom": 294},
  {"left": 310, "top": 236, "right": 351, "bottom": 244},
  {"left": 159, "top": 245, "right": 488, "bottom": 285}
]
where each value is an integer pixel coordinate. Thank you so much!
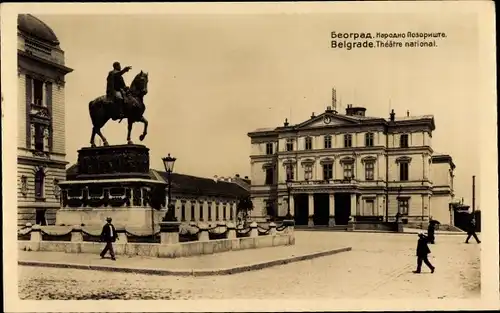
[{"left": 56, "top": 145, "right": 166, "bottom": 228}]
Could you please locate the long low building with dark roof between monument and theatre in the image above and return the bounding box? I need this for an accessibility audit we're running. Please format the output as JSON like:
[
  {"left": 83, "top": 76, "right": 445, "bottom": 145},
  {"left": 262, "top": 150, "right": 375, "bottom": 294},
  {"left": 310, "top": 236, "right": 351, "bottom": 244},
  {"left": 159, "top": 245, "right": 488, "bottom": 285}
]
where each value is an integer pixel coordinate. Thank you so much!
[{"left": 66, "top": 164, "right": 250, "bottom": 222}]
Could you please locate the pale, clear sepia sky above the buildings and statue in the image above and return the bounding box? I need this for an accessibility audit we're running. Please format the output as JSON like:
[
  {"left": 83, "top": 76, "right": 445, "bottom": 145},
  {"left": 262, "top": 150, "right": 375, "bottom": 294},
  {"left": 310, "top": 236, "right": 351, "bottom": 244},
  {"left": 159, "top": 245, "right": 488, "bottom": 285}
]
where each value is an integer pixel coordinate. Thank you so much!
[{"left": 37, "top": 12, "right": 480, "bottom": 203}]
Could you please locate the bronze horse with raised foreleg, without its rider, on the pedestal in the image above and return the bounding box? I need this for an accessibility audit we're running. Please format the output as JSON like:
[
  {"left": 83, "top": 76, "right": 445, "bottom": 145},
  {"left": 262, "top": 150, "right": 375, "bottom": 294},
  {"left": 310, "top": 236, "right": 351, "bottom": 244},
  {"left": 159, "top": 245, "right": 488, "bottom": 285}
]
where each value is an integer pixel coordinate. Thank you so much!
[{"left": 89, "top": 71, "right": 148, "bottom": 147}]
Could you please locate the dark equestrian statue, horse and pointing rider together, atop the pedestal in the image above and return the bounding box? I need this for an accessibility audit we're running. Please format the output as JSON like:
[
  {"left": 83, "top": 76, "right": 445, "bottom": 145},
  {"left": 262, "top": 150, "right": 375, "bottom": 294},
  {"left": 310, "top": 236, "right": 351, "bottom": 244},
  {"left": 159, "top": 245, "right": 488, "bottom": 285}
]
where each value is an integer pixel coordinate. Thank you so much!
[{"left": 89, "top": 62, "right": 148, "bottom": 147}]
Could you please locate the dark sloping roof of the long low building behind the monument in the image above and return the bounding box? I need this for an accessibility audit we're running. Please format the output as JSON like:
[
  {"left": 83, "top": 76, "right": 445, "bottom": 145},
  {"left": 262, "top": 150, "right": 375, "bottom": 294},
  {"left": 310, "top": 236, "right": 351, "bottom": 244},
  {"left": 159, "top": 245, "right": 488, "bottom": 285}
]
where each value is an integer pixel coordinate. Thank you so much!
[{"left": 66, "top": 164, "right": 249, "bottom": 198}]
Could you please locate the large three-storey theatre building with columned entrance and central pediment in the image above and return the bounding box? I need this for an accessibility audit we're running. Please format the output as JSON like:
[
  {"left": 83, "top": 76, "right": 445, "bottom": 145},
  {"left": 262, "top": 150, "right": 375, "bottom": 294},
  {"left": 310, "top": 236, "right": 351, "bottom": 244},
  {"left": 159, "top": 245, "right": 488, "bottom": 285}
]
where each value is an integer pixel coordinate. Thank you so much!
[{"left": 248, "top": 105, "right": 455, "bottom": 226}]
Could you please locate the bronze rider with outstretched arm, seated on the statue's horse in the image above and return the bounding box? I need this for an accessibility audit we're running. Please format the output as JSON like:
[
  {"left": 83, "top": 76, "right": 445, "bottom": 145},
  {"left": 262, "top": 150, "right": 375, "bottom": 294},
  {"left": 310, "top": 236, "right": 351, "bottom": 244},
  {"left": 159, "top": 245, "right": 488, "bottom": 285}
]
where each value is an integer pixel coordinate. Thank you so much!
[{"left": 106, "top": 62, "right": 132, "bottom": 120}]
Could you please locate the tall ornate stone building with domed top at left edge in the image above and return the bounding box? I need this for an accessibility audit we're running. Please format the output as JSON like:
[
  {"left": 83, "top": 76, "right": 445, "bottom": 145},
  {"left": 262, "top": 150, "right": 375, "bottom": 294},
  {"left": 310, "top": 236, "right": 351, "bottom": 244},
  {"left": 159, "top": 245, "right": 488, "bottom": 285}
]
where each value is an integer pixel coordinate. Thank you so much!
[{"left": 17, "top": 14, "right": 73, "bottom": 226}]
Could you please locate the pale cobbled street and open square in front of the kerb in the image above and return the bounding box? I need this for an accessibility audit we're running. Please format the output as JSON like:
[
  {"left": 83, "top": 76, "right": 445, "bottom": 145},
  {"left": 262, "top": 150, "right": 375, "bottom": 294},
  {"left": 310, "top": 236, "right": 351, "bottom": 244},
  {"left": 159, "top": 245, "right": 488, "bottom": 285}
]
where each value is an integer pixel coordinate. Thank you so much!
[{"left": 19, "top": 231, "right": 481, "bottom": 300}]
